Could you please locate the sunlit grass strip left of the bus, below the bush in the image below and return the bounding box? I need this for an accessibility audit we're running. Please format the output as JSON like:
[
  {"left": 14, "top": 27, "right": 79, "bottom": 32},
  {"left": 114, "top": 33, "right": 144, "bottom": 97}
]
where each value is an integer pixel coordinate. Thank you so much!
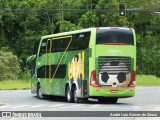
[{"left": 0, "top": 80, "right": 31, "bottom": 90}]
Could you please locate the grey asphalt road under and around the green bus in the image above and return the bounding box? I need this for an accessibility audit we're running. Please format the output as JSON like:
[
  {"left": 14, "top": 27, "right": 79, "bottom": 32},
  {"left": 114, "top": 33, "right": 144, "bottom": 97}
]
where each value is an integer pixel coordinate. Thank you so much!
[{"left": 0, "top": 87, "right": 160, "bottom": 120}]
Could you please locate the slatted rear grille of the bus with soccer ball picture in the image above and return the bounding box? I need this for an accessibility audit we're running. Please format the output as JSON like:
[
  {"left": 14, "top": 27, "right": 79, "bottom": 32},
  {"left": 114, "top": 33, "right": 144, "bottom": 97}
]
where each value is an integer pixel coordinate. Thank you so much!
[{"left": 98, "top": 56, "right": 133, "bottom": 87}]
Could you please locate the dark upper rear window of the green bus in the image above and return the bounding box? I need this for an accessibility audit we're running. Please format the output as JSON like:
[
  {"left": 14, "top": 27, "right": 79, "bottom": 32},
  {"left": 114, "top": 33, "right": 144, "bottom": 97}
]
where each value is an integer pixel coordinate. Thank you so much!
[{"left": 96, "top": 29, "right": 134, "bottom": 45}]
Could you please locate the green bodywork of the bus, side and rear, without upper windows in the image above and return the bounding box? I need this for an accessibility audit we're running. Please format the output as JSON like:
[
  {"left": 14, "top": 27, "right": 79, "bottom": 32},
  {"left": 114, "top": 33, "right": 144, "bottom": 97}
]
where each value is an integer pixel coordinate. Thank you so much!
[{"left": 27, "top": 28, "right": 136, "bottom": 101}]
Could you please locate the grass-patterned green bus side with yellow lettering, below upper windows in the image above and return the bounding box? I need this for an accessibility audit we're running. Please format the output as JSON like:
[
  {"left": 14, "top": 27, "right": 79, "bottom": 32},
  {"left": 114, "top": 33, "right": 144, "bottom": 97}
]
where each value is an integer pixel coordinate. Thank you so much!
[{"left": 32, "top": 37, "right": 89, "bottom": 97}]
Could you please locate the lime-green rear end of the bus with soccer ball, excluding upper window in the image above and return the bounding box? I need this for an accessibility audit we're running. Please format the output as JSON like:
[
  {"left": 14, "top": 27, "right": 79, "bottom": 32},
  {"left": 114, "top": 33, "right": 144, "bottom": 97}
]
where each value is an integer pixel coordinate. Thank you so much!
[{"left": 89, "top": 28, "right": 136, "bottom": 97}]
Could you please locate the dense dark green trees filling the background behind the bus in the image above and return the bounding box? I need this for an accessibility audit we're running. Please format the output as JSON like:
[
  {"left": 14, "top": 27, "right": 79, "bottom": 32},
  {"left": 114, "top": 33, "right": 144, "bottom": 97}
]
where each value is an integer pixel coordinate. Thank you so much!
[{"left": 0, "top": 0, "right": 160, "bottom": 78}]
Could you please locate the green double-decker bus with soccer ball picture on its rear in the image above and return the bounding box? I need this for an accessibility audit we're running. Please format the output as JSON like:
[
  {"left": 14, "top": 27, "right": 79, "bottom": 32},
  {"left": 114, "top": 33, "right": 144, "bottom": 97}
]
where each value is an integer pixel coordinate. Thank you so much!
[{"left": 27, "top": 27, "right": 136, "bottom": 103}]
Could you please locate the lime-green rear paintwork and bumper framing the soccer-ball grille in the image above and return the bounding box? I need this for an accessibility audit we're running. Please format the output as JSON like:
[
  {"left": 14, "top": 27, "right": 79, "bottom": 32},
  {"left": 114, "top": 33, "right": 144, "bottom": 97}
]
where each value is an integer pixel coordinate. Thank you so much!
[{"left": 89, "top": 45, "right": 136, "bottom": 97}]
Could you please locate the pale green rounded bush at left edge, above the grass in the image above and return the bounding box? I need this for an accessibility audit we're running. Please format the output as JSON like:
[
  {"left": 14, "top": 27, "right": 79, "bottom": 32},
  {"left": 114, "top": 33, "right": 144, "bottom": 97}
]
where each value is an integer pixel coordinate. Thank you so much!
[{"left": 0, "top": 50, "right": 21, "bottom": 81}]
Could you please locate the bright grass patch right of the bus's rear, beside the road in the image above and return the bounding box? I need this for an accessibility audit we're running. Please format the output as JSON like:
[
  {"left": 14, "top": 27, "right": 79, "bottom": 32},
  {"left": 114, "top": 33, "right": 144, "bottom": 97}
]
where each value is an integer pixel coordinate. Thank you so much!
[{"left": 136, "top": 75, "right": 160, "bottom": 86}]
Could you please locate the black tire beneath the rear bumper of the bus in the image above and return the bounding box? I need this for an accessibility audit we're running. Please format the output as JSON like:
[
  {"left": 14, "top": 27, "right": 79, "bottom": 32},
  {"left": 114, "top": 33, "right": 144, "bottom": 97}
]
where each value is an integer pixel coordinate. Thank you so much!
[{"left": 98, "top": 98, "right": 118, "bottom": 104}]
